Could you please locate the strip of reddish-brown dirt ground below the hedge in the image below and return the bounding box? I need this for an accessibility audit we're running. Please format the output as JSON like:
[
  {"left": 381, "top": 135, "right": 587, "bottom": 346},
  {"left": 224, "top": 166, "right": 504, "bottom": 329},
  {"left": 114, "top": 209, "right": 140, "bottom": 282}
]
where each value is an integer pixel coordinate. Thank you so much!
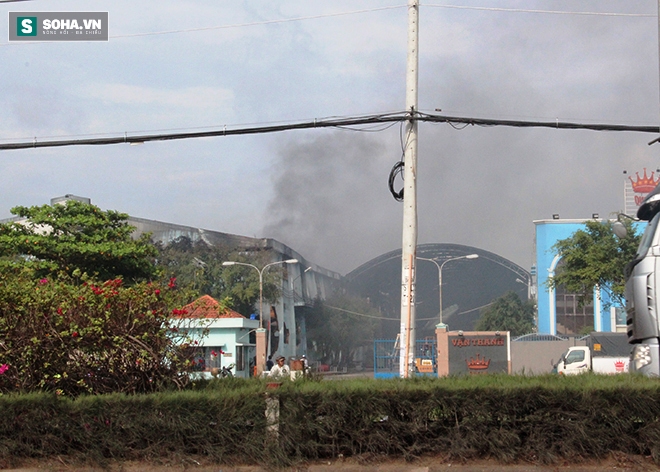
[{"left": 5, "top": 455, "right": 660, "bottom": 472}]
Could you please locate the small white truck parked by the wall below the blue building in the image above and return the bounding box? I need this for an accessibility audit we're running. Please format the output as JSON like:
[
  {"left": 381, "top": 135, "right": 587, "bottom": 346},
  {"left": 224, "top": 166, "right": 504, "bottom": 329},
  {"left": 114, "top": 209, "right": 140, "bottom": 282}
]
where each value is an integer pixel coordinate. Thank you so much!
[{"left": 554, "top": 332, "right": 630, "bottom": 375}]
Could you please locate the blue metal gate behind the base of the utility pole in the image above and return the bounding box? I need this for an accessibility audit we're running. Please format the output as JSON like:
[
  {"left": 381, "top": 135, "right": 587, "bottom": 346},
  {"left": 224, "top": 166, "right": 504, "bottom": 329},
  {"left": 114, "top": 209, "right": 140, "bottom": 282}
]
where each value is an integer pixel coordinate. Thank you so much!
[{"left": 374, "top": 338, "right": 438, "bottom": 379}]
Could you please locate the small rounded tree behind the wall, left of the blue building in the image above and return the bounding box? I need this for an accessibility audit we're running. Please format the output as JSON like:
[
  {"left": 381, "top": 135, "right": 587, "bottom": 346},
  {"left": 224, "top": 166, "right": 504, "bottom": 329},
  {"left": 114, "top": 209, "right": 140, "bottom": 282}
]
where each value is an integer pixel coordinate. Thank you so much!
[{"left": 475, "top": 292, "right": 535, "bottom": 336}]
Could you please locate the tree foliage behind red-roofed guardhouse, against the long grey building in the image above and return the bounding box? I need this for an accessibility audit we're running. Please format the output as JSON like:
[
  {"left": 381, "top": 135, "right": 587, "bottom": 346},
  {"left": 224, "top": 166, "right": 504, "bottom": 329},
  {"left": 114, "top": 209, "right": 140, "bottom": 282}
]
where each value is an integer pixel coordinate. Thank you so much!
[{"left": 158, "top": 236, "right": 283, "bottom": 316}]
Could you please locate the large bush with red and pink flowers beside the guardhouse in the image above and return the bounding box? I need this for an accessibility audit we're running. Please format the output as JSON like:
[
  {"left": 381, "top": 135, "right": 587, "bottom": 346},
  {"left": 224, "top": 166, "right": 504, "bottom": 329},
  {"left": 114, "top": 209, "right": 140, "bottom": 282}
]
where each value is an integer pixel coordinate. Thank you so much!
[{"left": 0, "top": 270, "right": 200, "bottom": 395}]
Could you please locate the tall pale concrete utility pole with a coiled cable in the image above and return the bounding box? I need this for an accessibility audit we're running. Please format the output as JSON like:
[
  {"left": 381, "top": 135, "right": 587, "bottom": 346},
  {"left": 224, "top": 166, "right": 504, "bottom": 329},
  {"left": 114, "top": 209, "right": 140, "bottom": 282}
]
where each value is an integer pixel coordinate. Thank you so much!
[{"left": 399, "top": 0, "right": 420, "bottom": 378}]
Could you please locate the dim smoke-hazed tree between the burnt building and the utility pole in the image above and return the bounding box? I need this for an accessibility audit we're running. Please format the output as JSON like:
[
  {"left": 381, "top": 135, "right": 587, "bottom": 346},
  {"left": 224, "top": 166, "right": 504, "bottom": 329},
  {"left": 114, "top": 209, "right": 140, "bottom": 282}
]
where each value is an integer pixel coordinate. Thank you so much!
[{"left": 305, "top": 292, "right": 380, "bottom": 365}]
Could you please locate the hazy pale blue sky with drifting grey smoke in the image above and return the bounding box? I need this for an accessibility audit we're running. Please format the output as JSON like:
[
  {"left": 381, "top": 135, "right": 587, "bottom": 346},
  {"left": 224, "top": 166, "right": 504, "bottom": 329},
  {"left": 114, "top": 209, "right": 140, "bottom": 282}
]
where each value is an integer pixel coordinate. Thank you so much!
[{"left": 0, "top": 0, "right": 660, "bottom": 273}]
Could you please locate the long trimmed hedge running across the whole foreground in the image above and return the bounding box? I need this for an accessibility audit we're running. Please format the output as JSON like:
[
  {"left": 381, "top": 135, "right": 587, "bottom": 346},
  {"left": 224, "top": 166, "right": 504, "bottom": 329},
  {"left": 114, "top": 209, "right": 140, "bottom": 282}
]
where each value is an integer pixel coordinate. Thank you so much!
[{"left": 0, "top": 375, "right": 660, "bottom": 467}]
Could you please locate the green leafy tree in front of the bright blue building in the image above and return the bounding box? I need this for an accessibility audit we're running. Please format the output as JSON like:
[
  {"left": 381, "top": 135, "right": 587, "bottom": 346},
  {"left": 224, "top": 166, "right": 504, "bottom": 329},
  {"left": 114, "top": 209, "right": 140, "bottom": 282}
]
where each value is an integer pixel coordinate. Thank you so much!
[{"left": 548, "top": 220, "right": 641, "bottom": 305}]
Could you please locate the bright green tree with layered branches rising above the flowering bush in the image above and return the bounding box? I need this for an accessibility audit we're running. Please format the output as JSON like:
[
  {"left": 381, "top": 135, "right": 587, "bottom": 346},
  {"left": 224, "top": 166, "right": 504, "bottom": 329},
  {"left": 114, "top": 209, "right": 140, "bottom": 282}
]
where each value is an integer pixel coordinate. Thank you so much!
[{"left": 0, "top": 201, "right": 158, "bottom": 282}]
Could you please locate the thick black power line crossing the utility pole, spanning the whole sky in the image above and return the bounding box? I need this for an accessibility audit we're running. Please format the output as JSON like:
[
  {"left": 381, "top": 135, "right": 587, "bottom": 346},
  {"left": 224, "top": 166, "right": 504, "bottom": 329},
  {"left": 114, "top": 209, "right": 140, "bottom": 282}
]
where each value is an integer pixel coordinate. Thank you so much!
[{"left": 0, "top": 111, "right": 660, "bottom": 151}]
